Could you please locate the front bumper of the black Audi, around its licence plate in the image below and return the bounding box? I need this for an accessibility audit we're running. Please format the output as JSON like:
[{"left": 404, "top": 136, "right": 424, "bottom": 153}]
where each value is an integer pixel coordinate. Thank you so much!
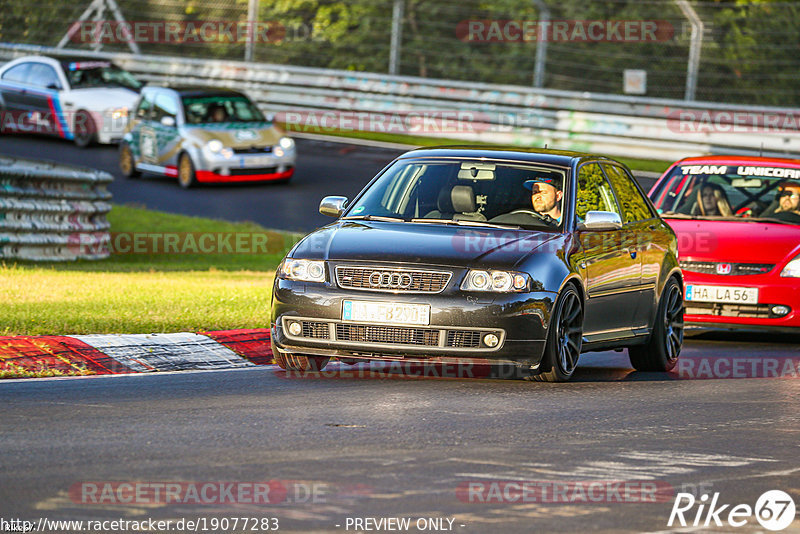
[{"left": 272, "top": 273, "right": 557, "bottom": 367}]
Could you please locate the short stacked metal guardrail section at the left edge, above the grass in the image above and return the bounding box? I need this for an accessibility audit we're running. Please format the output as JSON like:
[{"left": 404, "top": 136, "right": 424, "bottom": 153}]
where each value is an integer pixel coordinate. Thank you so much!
[{"left": 0, "top": 156, "right": 113, "bottom": 261}]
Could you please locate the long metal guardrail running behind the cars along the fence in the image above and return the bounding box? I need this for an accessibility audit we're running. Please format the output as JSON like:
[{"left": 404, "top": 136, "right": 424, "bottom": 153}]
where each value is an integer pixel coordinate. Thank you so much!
[{"left": 0, "top": 43, "right": 800, "bottom": 160}]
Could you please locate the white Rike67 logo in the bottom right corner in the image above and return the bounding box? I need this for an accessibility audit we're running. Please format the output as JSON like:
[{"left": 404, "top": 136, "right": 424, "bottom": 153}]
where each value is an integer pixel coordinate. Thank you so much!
[{"left": 667, "top": 490, "right": 796, "bottom": 531}]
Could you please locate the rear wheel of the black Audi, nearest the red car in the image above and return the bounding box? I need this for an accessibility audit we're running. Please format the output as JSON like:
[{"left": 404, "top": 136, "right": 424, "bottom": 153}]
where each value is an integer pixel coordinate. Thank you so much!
[{"left": 628, "top": 278, "right": 684, "bottom": 372}]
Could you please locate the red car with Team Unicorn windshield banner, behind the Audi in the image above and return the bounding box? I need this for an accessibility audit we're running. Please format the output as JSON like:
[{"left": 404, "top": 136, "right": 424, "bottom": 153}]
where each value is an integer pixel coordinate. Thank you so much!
[{"left": 650, "top": 156, "right": 800, "bottom": 333}]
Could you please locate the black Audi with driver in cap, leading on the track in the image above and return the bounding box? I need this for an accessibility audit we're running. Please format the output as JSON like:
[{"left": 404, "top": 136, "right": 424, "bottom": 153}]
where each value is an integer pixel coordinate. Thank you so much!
[{"left": 272, "top": 147, "right": 684, "bottom": 381}]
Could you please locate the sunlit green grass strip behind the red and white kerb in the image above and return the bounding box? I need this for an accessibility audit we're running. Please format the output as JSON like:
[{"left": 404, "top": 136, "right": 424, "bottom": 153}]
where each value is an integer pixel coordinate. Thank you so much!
[{"left": 0, "top": 205, "right": 299, "bottom": 335}]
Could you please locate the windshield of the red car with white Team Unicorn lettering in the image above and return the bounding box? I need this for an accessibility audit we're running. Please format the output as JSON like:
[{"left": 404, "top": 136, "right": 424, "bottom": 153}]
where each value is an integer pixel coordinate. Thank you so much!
[{"left": 650, "top": 165, "right": 800, "bottom": 224}]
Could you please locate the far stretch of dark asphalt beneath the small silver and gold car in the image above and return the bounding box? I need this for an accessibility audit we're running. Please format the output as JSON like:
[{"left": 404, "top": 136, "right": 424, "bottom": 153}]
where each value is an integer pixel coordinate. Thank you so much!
[{"left": 0, "top": 135, "right": 652, "bottom": 232}]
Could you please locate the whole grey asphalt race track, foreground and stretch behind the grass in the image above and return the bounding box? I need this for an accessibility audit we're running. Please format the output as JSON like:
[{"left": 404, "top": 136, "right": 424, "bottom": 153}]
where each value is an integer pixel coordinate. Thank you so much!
[{"left": 0, "top": 137, "right": 800, "bottom": 533}]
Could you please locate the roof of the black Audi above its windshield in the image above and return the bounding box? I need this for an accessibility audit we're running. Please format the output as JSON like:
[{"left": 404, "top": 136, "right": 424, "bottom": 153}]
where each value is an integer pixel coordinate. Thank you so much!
[{"left": 400, "top": 145, "right": 619, "bottom": 167}]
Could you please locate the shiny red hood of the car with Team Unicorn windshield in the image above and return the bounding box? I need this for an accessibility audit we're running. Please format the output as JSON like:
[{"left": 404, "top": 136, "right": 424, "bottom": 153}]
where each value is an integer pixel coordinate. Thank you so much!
[{"left": 667, "top": 219, "right": 800, "bottom": 264}]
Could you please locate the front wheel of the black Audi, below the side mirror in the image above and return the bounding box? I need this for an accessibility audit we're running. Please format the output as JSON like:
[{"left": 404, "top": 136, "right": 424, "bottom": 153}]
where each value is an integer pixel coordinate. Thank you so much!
[{"left": 530, "top": 284, "right": 583, "bottom": 382}]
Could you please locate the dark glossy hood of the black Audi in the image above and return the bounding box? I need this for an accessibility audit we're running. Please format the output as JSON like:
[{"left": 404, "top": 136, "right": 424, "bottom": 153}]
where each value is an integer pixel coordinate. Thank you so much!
[{"left": 291, "top": 221, "right": 560, "bottom": 268}]
